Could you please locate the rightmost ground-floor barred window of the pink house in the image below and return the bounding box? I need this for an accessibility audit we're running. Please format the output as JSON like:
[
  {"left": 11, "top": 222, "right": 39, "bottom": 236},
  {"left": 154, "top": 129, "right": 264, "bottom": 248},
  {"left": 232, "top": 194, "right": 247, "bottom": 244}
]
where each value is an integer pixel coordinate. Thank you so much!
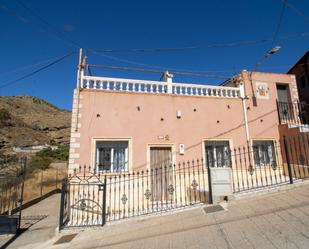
[{"left": 252, "top": 140, "right": 277, "bottom": 166}]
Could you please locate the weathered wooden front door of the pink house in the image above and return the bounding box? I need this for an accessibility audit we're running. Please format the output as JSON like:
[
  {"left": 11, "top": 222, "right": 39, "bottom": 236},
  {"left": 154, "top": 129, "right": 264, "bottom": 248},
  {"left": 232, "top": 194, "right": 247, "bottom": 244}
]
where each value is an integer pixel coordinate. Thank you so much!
[{"left": 150, "top": 147, "right": 173, "bottom": 201}]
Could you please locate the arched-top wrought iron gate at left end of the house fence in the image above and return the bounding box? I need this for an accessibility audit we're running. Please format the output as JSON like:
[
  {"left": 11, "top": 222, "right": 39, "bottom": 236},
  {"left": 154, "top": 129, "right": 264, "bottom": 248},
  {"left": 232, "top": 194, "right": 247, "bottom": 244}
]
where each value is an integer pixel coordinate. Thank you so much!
[{"left": 59, "top": 168, "right": 106, "bottom": 229}]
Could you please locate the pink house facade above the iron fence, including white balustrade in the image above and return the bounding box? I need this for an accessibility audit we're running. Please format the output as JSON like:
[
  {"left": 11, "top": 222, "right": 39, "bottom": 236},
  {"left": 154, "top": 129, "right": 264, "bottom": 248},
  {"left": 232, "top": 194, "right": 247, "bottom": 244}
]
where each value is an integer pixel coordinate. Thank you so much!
[{"left": 69, "top": 55, "right": 298, "bottom": 173}]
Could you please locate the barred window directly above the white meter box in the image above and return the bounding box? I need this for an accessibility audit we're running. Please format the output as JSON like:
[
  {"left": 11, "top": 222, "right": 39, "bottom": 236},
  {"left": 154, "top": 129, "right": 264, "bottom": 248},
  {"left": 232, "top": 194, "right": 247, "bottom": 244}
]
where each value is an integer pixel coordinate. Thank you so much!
[{"left": 205, "top": 141, "right": 231, "bottom": 167}]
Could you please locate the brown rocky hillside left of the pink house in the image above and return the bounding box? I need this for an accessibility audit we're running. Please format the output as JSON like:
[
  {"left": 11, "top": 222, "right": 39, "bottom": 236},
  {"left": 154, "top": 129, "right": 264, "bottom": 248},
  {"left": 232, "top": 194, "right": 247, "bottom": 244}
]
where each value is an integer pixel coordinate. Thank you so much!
[{"left": 0, "top": 96, "right": 71, "bottom": 154}]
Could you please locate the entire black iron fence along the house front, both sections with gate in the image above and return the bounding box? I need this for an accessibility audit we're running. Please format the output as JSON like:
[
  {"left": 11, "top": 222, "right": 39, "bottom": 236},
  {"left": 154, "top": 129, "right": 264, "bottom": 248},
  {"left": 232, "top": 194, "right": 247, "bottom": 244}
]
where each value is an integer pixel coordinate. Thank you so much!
[{"left": 60, "top": 134, "right": 309, "bottom": 229}]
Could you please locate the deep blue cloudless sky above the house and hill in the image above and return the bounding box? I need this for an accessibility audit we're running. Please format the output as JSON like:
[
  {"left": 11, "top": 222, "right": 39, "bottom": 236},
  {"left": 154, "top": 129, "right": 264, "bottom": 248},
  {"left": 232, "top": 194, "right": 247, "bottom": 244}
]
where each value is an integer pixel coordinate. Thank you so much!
[{"left": 0, "top": 0, "right": 309, "bottom": 109}]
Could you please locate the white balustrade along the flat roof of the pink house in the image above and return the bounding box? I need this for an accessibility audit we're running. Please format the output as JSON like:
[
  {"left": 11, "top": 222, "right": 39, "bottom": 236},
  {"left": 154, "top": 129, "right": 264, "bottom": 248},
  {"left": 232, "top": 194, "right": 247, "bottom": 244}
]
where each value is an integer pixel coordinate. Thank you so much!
[{"left": 80, "top": 76, "right": 240, "bottom": 98}]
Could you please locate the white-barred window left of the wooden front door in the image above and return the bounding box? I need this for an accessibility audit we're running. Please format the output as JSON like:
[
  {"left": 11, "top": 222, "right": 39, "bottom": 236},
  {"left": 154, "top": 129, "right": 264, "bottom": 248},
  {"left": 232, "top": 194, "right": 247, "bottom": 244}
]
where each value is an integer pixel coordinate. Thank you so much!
[{"left": 96, "top": 141, "right": 128, "bottom": 172}]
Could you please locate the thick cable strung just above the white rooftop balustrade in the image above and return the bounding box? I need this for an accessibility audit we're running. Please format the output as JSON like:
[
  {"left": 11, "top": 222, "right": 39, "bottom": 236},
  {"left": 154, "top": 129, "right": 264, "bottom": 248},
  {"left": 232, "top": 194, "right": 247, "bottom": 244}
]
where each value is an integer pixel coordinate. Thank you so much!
[{"left": 88, "top": 64, "right": 229, "bottom": 79}]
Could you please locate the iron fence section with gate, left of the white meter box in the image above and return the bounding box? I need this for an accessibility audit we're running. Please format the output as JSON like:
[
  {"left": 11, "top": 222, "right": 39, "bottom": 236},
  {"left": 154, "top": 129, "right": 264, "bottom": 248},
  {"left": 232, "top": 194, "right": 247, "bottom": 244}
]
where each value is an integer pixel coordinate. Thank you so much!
[{"left": 60, "top": 160, "right": 212, "bottom": 228}]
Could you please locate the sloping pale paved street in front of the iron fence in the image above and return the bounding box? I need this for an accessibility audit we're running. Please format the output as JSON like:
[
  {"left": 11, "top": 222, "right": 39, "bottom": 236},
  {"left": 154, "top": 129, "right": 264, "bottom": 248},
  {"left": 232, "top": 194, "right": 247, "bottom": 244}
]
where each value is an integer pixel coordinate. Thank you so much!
[{"left": 38, "top": 184, "right": 309, "bottom": 249}]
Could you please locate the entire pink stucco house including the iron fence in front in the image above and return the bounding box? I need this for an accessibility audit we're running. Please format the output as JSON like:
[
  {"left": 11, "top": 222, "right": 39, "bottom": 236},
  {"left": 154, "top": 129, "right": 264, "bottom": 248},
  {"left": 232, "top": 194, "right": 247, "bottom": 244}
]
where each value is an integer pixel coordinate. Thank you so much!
[{"left": 61, "top": 53, "right": 309, "bottom": 229}]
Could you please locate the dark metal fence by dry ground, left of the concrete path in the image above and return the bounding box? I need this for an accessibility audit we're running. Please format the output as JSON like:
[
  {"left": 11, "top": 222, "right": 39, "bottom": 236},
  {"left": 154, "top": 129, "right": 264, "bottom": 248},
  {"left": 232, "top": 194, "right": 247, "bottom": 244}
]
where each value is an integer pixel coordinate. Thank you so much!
[{"left": 0, "top": 158, "right": 67, "bottom": 233}]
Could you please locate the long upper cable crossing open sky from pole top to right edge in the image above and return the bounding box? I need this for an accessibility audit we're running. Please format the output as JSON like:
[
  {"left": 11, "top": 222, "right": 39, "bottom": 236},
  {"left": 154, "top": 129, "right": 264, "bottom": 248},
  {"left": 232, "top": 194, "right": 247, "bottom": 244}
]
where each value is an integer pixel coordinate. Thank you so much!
[{"left": 87, "top": 31, "right": 309, "bottom": 53}]
